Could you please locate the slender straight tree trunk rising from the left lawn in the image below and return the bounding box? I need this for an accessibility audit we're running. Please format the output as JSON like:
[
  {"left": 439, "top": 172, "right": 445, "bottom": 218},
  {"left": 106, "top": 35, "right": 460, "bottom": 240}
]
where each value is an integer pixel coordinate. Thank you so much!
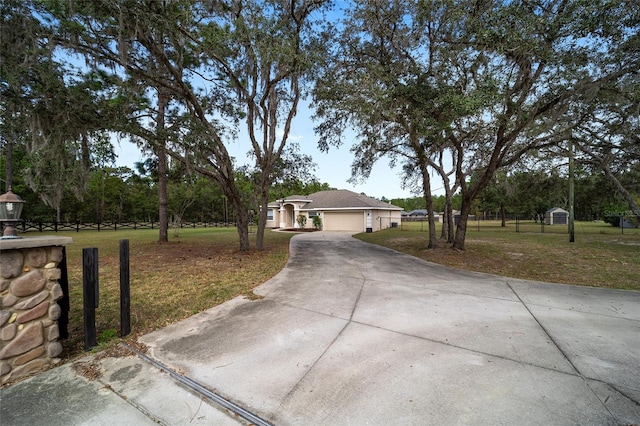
[{"left": 155, "top": 89, "right": 169, "bottom": 243}]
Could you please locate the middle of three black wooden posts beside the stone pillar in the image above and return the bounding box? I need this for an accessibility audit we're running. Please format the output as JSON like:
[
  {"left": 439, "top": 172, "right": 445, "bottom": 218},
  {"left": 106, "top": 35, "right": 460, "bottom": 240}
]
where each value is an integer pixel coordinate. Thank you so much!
[{"left": 82, "top": 247, "right": 99, "bottom": 350}]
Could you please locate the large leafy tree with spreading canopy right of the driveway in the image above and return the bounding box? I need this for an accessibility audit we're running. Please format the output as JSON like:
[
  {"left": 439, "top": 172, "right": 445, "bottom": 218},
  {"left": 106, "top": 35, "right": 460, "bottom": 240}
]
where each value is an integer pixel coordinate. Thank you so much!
[{"left": 315, "top": 0, "right": 640, "bottom": 249}]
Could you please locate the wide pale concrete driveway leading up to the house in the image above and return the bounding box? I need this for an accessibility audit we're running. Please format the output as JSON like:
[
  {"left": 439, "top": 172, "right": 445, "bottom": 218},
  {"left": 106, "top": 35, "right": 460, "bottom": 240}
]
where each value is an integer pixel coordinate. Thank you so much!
[{"left": 1, "top": 232, "right": 640, "bottom": 425}]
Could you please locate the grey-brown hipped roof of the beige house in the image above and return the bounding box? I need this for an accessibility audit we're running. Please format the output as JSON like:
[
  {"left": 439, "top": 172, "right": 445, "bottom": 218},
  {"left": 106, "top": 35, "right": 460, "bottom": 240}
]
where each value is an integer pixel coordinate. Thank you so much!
[{"left": 278, "top": 189, "right": 402, "bottom": 210}]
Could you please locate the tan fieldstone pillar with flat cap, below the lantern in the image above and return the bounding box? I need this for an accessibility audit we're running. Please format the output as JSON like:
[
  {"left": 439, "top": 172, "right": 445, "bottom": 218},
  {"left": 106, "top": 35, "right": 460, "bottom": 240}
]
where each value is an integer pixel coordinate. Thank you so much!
[{"left": 0, "top": 237, "right": 73, "bottom": 384}]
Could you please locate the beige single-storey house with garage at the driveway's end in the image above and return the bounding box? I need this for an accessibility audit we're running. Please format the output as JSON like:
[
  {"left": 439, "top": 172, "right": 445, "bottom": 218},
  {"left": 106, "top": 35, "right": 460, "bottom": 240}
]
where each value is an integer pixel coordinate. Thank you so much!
[{"left": 267, "top": 189, "right": 402, "bottom": 233}]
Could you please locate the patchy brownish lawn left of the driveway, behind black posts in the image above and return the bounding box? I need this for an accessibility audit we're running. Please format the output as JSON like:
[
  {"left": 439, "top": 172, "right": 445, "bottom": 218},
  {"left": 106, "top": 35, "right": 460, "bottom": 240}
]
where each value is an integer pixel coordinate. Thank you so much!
[{"left": 41, "top": 228, "right": 293, "bottom": 360}]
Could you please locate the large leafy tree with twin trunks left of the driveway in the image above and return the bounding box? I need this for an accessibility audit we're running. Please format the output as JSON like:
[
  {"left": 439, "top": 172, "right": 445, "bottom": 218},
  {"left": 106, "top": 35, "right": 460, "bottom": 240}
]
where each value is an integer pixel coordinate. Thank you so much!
[{"left": 9, "top": 0, "right": 326, "bottom": 250}]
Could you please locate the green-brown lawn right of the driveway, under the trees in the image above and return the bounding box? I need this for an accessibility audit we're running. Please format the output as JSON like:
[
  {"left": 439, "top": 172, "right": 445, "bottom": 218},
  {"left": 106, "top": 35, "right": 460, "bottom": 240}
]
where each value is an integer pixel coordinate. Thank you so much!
[{"left": 358, "top": 221, "right": 640, "bottom": 290}]
